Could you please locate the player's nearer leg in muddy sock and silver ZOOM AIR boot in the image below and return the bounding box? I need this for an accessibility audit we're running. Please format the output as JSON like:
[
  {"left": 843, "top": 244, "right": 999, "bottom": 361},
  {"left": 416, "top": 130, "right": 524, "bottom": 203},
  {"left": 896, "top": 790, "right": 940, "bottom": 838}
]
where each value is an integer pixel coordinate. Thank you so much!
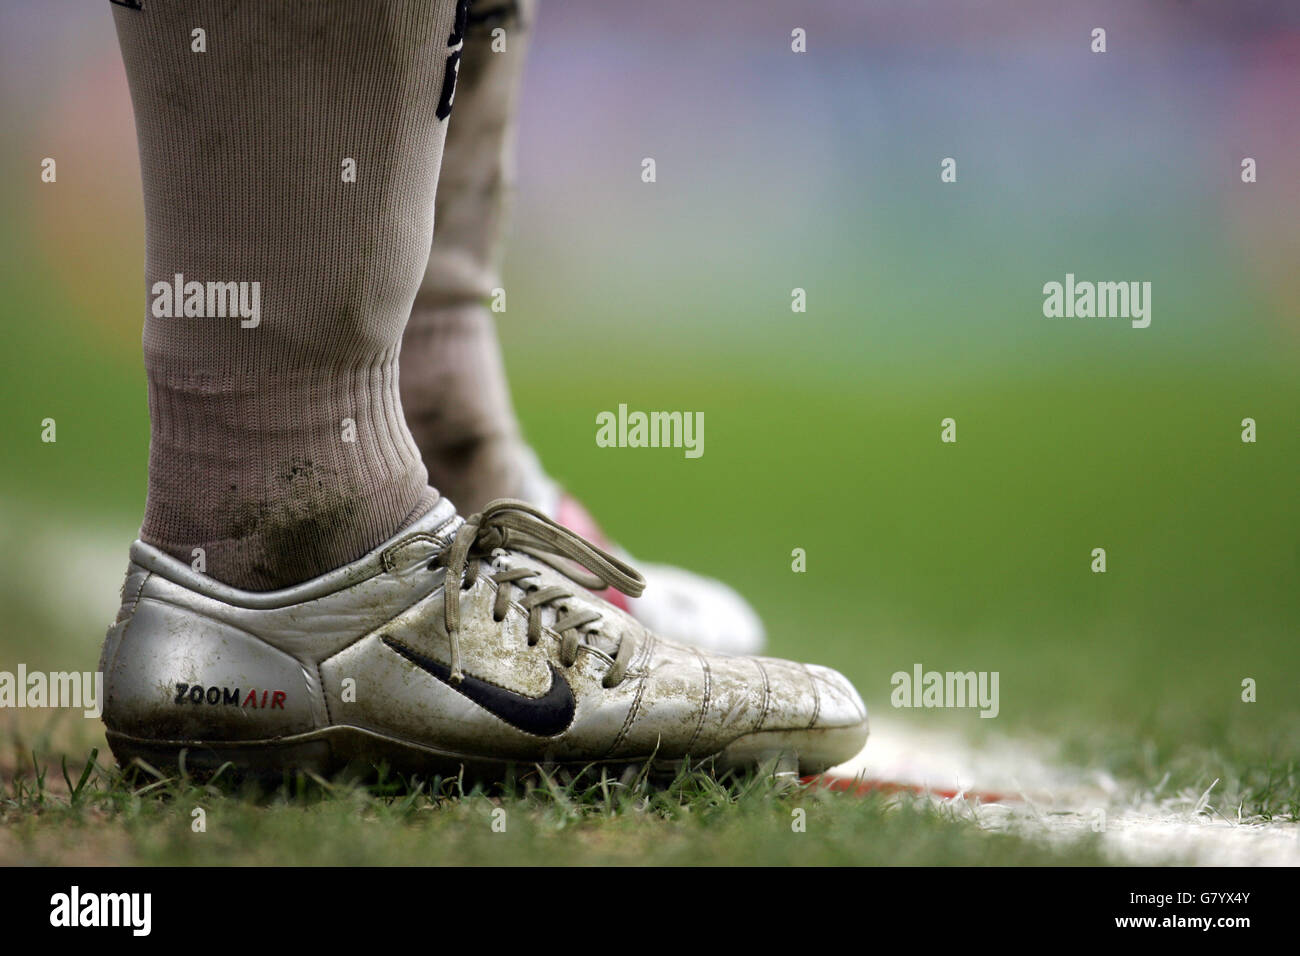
[{"left": 94, "top": 0, "right": 866, "bottom": 778}]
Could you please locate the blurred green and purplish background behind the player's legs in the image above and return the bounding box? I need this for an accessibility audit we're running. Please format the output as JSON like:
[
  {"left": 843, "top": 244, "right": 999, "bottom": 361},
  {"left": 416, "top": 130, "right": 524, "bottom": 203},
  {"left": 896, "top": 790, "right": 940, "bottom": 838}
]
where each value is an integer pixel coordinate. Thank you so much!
[{"left": 0, "top": 0, "right": 1300, "bottom": 769}]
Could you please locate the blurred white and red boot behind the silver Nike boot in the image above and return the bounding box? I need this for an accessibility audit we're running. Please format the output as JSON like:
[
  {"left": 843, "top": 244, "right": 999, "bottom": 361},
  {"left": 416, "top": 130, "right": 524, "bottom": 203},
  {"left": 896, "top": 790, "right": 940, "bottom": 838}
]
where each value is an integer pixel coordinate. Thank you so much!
[{"left": 520, "top": 447, "right": 766, "bottom": 654}]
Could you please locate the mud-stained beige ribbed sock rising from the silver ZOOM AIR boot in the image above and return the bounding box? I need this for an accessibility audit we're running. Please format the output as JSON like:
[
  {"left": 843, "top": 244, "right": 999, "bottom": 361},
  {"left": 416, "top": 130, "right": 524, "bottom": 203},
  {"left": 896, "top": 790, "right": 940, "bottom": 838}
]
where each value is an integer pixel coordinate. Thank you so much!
[{"left": 113, "top": 0, "right": 464, "bottom": 591}]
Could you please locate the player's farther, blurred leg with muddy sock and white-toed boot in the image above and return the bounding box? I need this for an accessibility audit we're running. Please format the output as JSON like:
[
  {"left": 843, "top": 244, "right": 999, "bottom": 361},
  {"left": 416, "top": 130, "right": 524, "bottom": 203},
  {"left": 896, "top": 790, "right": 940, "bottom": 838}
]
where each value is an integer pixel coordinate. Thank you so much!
[{"left": 402, "top": 0, "right": 763, "bottom": 653}]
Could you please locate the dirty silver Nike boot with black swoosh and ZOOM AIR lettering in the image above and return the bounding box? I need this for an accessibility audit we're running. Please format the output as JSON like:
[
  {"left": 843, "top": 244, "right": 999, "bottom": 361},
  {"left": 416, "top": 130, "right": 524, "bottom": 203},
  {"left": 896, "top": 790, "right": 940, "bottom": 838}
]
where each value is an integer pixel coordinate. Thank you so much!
[{"left": 100, "top": 499, "right": 867, "bottom": 778}]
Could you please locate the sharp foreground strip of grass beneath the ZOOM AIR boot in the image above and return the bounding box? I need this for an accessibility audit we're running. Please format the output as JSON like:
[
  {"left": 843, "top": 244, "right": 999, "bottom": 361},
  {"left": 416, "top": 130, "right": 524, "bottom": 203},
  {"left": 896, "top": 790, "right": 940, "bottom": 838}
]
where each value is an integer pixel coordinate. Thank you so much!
[{"left": 0, "top": 741, "right": 1118, "bottom": 865}]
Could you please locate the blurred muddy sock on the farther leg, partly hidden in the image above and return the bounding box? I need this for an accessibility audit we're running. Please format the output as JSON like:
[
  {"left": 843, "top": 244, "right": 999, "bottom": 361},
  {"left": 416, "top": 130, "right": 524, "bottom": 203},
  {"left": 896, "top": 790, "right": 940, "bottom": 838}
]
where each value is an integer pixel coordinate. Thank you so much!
[{"left": 402, "top": 0, "right": 536, "bottom": 514}]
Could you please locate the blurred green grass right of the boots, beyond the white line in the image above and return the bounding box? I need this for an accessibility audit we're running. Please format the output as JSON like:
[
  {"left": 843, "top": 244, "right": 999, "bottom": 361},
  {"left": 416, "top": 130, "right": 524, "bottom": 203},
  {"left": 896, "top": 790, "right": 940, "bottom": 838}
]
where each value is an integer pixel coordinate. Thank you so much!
[{"left": 506, "top": 348, "right": 1300, "bottom": 761}]
